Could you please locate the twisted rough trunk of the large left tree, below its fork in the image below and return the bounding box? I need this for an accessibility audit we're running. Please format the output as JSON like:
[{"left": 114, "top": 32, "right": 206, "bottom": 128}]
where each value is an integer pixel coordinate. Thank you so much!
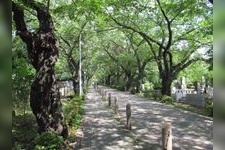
[{"left": 29, "top": 38, "right": 68, "bottom": 137}]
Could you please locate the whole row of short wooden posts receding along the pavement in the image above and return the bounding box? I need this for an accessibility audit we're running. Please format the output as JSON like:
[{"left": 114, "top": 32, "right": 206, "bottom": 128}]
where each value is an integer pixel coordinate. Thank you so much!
[{"left": 95, "top": 86, "right": 172, "bottom": 150}]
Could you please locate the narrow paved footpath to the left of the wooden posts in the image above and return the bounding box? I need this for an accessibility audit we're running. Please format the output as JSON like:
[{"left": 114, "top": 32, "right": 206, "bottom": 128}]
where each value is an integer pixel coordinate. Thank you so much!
[{"left": 75, "top": 88, "right": 138, "bottom": 150}]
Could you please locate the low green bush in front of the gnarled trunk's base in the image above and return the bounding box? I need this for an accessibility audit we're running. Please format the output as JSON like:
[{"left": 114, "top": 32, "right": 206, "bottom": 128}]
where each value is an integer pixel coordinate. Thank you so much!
[{"left": 34, "top": 132, "right": 63, "bottom": 150}]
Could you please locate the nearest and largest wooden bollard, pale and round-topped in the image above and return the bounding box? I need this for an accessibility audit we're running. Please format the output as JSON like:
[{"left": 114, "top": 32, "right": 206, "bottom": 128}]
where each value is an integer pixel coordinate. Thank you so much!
[{"left": 162, "top": 123, "right": 172, "bottom": 150}]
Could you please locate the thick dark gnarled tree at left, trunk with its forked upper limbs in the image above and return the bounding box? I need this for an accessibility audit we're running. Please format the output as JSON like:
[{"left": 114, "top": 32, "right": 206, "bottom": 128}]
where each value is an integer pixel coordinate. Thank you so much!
[{"left": 12, "top": 0, "right": 68, "bottom": 138}]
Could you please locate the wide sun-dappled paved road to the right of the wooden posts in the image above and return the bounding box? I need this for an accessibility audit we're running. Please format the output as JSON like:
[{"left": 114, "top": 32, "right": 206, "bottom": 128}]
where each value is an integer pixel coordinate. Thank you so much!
[{"left": 99, "top": 87, "right": 213, "bottom": 150}]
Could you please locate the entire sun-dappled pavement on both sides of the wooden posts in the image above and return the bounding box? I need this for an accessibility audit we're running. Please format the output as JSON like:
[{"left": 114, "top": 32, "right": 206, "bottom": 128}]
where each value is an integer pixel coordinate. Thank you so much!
[{"left": 74, "top": 86, "right": 213, "bottom": 150}]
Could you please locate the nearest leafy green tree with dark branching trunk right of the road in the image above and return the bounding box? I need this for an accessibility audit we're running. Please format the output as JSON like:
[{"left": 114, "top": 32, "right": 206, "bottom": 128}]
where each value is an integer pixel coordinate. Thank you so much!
[{"left": 108, "top": 0, "right": 212, "bottom": 95}]
